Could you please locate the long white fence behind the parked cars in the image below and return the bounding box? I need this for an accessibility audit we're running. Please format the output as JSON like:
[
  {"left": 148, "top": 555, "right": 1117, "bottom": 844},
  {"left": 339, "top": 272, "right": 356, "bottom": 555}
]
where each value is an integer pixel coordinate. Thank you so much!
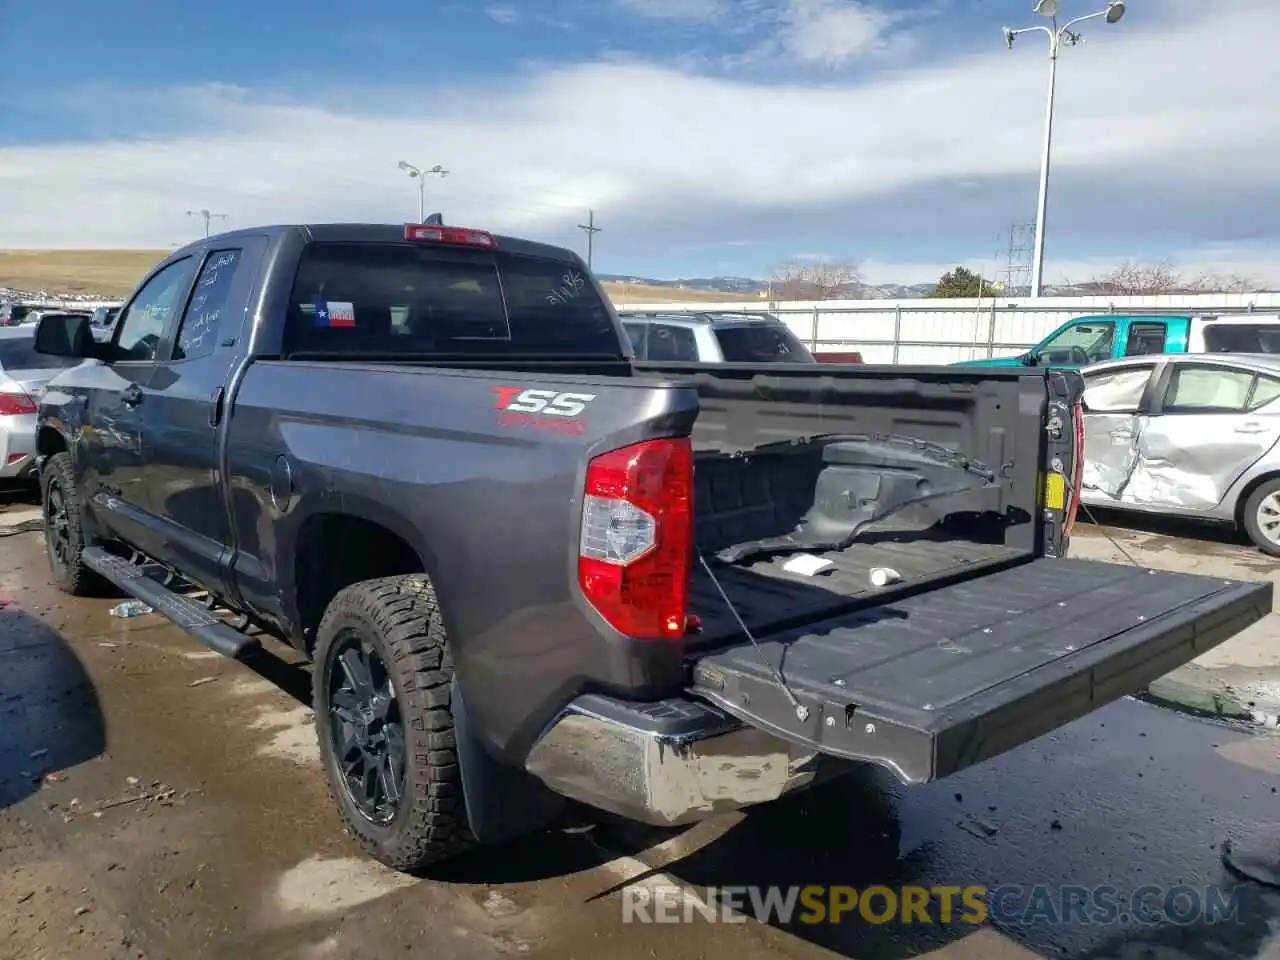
[{"left": 618, "top": 293, "right": 1280, "bottom": 364}]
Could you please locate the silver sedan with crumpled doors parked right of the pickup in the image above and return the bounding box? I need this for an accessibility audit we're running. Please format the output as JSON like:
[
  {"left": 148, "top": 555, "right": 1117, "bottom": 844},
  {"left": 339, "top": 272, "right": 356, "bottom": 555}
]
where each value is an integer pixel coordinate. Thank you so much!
[{"left": 1082, "top": 353, "right": 1280, "bottom": 557}]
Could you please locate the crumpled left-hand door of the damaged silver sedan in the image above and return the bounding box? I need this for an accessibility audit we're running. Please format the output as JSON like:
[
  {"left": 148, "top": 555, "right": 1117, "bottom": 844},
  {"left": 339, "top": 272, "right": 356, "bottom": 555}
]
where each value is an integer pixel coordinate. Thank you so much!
[{"left": 1080, "top": 362, "right": 1160, "bottom": 502}]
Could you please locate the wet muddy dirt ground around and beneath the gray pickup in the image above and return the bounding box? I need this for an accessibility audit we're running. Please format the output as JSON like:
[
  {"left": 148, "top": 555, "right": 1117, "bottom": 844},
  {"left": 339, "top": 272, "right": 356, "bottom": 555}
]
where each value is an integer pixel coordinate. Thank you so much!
[{"left": 0, "top": 506, "right": 1280, "bottom": 960}]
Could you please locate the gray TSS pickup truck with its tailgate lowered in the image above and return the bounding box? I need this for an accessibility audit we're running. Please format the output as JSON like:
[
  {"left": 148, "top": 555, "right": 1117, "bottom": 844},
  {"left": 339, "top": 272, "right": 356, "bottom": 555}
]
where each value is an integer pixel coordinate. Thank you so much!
[{"left": 30, "top": 224, "right": 1271, "bottom": 869}]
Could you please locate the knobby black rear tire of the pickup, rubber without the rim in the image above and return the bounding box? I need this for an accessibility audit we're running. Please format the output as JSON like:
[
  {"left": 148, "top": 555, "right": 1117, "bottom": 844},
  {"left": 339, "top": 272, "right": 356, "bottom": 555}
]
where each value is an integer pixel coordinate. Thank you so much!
[{"left": 312, "top": 575, "right": 475, "bottom": 872}]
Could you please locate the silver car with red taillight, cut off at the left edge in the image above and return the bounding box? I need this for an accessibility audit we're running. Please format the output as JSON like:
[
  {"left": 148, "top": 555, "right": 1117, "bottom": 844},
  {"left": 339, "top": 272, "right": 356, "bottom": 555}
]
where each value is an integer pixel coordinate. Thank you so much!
[{"left": 0, "top": 325, "right": 79, "bottom": 480}]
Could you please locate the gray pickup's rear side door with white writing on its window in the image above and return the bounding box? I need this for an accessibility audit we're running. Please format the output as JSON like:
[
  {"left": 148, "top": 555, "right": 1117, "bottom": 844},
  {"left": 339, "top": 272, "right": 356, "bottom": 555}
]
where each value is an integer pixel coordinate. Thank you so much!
[{"left": 135, "top": 237, "right": 266, "bottom": 595}]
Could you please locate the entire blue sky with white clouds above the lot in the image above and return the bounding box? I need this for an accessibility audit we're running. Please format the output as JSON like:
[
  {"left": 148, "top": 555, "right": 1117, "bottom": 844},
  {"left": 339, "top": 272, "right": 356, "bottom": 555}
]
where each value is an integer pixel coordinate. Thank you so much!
[{"left": 0, "top": 0, "right": 1280, "bottom": 283}]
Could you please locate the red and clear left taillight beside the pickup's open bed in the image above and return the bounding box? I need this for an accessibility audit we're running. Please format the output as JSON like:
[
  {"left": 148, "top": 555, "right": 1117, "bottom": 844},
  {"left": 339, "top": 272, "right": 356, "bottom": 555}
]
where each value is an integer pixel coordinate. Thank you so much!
[{"left": 577, "top": 436, "right": 694, "bottom": 640}]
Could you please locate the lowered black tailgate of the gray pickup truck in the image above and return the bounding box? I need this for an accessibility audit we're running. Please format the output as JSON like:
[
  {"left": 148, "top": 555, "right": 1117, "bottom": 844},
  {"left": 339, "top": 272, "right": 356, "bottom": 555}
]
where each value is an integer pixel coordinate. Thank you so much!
[{"left": 691, "top": 559, "right": 1272, "bottom": 782}]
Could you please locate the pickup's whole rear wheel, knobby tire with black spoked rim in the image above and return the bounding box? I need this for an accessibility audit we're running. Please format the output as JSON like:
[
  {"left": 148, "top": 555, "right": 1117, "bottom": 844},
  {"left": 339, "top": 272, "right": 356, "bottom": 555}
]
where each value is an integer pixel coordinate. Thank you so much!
[{"left": 312, "top": 575, "right": 475, "bottom": 870}]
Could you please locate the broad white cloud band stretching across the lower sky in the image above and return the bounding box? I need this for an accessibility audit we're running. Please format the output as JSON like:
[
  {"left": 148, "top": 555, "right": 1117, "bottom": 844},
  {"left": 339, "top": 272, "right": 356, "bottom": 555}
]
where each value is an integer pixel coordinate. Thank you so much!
[{"left": 0, "top": 0, "right": 1280, "bottom": 285}]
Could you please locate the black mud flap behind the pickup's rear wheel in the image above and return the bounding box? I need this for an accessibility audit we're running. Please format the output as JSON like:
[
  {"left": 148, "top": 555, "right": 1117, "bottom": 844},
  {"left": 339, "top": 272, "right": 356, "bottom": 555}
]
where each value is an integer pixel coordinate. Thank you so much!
[{"left": 449, "top": 677, "right": 564, "bottom": 844}]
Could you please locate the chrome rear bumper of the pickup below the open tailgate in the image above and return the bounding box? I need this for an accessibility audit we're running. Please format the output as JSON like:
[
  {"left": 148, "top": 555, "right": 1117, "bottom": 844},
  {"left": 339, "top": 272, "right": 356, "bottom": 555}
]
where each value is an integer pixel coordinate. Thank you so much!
[{"left": 525, "top": 696, "right": 822, "bottom": 827}]
